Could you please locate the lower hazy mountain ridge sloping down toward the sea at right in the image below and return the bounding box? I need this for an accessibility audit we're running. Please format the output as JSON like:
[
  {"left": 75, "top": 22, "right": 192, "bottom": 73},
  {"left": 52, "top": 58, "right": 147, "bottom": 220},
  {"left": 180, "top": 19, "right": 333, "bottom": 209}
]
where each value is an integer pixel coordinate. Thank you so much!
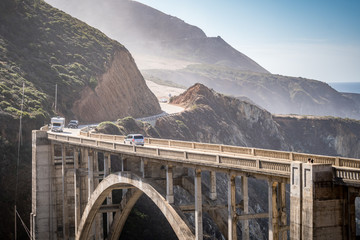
[{"left": 142, "top": 64, "right": 360, "bottom": 119}]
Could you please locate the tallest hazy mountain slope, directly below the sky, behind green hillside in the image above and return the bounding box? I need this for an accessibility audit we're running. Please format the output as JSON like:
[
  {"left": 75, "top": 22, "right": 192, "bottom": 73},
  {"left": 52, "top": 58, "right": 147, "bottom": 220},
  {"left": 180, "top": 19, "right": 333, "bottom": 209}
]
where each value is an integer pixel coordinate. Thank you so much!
[{"left": 47, "top": 0, "right": 268, "bottom": 73}]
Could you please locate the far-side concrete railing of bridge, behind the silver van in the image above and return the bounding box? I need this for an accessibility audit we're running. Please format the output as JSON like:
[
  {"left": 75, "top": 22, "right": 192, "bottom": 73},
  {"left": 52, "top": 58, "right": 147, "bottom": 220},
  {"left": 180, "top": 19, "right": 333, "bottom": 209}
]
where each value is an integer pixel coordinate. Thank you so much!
[{"left": 75, "top": 132, "right": 360, "bottom": 169}]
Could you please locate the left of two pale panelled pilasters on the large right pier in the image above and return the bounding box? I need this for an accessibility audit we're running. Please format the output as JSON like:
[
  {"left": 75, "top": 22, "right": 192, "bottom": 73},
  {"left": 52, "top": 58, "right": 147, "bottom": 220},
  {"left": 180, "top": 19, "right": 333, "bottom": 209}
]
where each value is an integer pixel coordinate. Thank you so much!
[{"left": 290, "top": 162, "right": 302, "bottom": 240}]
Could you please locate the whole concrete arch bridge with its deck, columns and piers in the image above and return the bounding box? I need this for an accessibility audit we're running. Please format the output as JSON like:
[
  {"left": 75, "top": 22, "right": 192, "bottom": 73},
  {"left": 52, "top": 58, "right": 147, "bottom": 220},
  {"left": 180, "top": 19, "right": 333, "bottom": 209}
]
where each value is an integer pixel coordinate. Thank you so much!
[{"left": 31, "top": 130, "right": 360, "bottom": 239}]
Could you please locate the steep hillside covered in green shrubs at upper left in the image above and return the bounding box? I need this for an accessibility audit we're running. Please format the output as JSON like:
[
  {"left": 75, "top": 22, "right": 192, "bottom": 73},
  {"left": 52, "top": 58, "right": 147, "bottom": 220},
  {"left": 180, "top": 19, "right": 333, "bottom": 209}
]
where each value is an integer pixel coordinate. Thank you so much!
[{"left": 0, "top": 0, "right": 122, "bottom": 118}]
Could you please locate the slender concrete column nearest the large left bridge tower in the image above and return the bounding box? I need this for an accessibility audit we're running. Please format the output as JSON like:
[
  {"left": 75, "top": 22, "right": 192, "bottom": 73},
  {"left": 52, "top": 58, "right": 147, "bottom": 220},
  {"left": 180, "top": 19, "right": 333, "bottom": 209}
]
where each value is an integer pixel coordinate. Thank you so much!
[{"left": 61, "top": 144, "right": 69, "bottom": 239}]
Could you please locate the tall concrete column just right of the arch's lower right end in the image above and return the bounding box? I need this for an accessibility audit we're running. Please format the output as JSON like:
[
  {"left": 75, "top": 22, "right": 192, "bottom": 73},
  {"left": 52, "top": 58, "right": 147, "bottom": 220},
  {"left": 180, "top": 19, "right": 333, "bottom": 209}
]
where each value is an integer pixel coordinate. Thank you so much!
[{"left": 194, "top": 169, "right": 203, "bottom": 240}]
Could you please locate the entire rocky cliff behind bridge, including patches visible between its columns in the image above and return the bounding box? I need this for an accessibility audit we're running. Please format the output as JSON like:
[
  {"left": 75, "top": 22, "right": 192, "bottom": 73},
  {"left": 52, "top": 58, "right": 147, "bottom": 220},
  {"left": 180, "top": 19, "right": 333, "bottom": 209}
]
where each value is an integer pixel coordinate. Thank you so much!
[{"left": 107, "top": 84, "right": 360, "bottom": 239}]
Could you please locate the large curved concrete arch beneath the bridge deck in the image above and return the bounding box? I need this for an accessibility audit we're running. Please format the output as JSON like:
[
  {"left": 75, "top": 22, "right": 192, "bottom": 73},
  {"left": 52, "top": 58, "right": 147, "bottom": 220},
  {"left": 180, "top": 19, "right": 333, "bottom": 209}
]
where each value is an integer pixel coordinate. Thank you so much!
[{"left": 76, "top": 172, "right": 195, "bottom": 240}]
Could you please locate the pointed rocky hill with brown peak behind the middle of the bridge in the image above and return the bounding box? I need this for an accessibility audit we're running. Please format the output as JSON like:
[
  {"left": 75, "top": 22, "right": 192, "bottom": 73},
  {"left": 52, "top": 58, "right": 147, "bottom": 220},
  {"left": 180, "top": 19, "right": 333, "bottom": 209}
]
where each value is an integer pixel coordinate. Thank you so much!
[{"left": 159, "top": 84, "right": 288, "bottom": 149}]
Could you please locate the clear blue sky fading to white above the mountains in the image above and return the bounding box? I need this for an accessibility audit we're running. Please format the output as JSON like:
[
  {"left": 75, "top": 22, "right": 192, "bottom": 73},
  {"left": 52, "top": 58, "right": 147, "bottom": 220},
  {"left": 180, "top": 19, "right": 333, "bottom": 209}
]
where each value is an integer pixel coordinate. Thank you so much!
[{"left": 138, "top": 0, "right": 360, "bottom": 82}]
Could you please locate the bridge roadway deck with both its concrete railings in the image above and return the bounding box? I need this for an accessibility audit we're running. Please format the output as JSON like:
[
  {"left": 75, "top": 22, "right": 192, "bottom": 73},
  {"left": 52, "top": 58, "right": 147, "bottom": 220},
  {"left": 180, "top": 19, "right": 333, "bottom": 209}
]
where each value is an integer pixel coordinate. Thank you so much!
[{"left": 48, "top": 132, "right": 360, "bottom": 184}]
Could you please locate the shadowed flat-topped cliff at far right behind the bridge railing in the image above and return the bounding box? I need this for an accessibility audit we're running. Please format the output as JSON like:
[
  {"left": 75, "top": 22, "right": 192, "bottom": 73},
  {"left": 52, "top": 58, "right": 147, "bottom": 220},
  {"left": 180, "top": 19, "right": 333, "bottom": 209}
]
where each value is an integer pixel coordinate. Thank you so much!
[{"left": 273, "top": 116, "right": 360, "bottom": 158}]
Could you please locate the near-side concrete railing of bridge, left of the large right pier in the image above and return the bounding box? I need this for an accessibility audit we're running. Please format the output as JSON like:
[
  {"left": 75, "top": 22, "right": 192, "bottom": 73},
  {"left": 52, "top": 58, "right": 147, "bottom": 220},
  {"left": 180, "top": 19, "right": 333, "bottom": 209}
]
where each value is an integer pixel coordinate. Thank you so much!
[{"left": 48, "top": 133, "right": 291, "bottom": 177}]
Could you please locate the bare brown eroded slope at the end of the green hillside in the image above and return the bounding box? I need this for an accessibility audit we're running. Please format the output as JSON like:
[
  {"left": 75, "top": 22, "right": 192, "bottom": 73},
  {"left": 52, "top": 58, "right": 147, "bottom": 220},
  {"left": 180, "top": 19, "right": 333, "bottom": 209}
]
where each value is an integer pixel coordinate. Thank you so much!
[{"left": 72, "top": 49, "right": 161, "bottom": 122}]
